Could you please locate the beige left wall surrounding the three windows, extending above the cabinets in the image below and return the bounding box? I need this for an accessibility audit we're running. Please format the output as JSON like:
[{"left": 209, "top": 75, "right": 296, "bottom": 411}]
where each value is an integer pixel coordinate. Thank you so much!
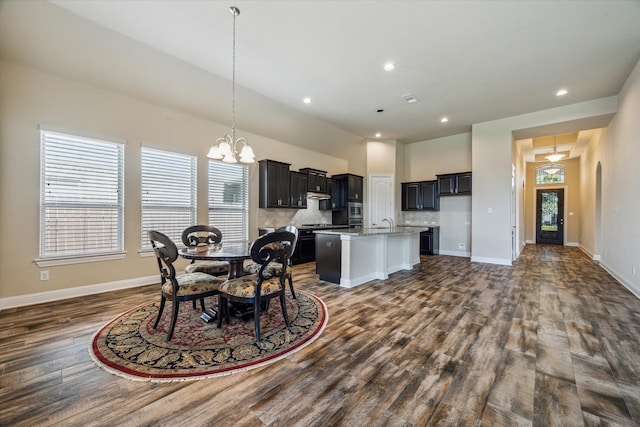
[{"left": 0, "top": 61, "right": 348, "bottom": 303}]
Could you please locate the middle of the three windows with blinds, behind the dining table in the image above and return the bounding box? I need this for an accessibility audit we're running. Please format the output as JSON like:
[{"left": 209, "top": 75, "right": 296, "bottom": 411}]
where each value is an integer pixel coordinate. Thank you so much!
[{"left": 141, "top": 147, "right": 197, "bottom": 249}]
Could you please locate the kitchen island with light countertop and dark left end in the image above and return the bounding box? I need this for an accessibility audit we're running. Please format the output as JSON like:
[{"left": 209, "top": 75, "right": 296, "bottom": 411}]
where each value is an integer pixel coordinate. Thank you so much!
[{"left": 315, "top": 227, "right": 427, "bottom": 288}]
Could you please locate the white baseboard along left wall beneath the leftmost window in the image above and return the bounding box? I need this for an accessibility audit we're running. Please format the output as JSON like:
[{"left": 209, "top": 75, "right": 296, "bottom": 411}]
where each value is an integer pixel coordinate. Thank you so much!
[{"left": 0, "top": 275, "right": 159, "bottom": 310}]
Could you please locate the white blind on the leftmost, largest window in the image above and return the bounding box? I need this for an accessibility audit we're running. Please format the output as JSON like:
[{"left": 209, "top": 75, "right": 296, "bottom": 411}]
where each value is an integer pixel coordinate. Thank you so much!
[{"left": 40, "top": 130, "right": 124, "bottom": 258}]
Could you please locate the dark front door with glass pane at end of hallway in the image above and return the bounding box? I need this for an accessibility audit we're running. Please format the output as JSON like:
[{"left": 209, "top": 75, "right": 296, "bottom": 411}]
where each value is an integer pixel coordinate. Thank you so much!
[{"left": 536, "top": 189, "right": 564, "bottom": 245}]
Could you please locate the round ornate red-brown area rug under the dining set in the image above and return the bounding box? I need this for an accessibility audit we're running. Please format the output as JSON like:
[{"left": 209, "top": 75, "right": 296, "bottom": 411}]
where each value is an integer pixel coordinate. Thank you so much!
[{"left": 89, "top": 290, "right": 328, "bottom": 382}]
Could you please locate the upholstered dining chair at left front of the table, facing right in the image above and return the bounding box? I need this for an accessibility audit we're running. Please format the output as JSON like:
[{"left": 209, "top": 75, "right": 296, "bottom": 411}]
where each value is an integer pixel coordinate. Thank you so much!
[{"left": 149, "top": 230, "right": 223, "bottom": 341}]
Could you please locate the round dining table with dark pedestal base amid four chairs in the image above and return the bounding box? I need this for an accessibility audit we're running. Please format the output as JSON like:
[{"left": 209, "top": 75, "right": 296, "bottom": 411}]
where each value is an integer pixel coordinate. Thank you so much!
[{"left": 178, "top": 240, "right": 251, "bottom": 279}]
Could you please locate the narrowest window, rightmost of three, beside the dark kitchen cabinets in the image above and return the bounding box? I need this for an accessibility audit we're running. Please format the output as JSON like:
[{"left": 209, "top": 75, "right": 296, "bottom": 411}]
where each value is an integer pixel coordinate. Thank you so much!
[{"left": 209, "top": 160, "right": 249, "bottom": 240}]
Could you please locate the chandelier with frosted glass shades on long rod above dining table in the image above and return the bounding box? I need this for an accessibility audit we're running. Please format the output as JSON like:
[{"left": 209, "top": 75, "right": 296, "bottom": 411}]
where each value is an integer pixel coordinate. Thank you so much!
[{"left": 207, "top": 6, "right": 255, "bottom": 163}]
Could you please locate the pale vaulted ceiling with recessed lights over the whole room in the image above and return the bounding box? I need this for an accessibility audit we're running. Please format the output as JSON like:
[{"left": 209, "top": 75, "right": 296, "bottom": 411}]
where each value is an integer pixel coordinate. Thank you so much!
[{"left": 0, "top": 0, "right": 640, "bottom": 158}]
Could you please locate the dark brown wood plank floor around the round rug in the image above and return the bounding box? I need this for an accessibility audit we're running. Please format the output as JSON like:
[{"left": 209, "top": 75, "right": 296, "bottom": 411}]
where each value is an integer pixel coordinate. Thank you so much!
[{"left": 0, "top": 245, "right": 640, "bottom": 426}]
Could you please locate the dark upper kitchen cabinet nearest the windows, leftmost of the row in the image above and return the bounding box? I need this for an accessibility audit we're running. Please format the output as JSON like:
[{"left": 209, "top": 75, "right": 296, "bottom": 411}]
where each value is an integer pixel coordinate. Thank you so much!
[{"left": 258, "top": 160, "right": 291, "bottom": 208}]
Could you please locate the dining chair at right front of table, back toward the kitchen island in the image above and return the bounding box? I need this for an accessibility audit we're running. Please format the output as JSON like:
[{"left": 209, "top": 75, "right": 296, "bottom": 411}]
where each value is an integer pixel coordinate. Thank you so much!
[{"left": 218, "top": 231, "right": 295, "bottom": 342}]
